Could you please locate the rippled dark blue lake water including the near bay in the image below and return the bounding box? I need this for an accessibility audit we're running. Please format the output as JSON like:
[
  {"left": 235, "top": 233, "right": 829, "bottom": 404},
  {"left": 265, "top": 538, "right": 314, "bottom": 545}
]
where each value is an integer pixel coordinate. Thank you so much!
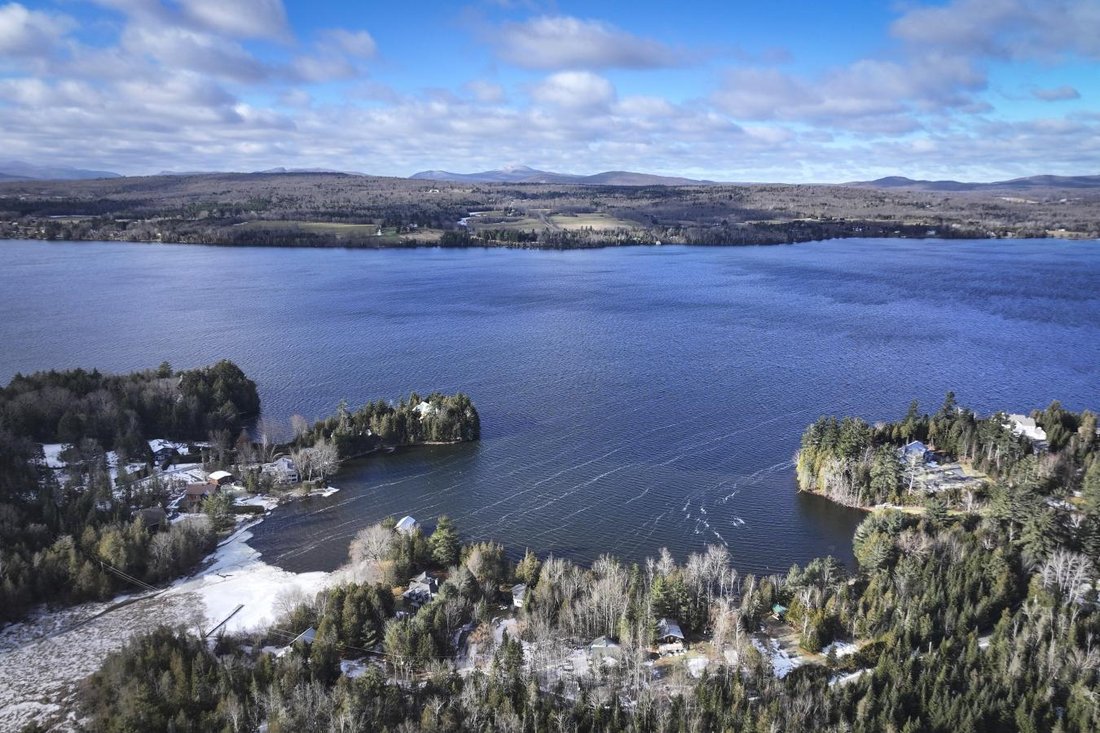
[{"left": 0, "top": 240, "right": 1100, "bottom": 571}]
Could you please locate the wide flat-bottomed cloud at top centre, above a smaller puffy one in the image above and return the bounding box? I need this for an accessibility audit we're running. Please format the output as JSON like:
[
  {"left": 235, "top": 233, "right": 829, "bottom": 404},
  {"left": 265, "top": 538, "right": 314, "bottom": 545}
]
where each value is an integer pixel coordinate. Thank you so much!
[{"left": 492, "top": 15, "right": 685, "bottom": 69}]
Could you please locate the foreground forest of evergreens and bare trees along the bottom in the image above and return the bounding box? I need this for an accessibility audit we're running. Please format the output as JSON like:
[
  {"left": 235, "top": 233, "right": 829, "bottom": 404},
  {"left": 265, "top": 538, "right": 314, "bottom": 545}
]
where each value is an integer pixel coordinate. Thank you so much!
[{"left": 83, "top": 484, "right": 1100, "bottom": 733}]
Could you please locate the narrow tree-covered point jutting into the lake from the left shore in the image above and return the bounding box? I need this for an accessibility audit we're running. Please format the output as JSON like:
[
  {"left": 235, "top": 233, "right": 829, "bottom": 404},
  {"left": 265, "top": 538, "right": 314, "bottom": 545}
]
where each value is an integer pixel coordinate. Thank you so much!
[{"left": 296, "top": 392, "right": 481, "bottom": 459}]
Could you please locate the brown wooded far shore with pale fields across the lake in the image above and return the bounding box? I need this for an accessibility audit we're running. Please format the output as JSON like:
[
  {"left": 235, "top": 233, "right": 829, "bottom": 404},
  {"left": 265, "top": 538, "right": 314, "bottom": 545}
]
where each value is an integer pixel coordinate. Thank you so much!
[{"left": 0, "top": 173, "right": 1100, "bottom": 249}]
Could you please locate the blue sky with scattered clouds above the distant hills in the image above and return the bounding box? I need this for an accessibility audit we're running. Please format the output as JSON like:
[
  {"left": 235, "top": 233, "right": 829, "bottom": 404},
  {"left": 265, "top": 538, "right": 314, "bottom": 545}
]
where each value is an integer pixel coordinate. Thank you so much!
[{"left": 0, "top": 0, "right": 1100, "bottom": 183}]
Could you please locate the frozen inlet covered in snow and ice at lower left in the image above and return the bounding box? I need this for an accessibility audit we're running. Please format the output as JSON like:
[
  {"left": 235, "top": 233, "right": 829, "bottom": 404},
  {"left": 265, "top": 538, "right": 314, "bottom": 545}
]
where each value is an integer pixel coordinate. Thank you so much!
[{"left": 0, "top": 519, "right": 339, "bottom": 731}]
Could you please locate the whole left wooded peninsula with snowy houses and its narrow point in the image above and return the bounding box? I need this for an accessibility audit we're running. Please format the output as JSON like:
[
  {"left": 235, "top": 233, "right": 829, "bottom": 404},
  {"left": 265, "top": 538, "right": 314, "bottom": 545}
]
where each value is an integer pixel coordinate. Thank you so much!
[{"left": 0, "top": 361, "right": 481, "bottom": 623}]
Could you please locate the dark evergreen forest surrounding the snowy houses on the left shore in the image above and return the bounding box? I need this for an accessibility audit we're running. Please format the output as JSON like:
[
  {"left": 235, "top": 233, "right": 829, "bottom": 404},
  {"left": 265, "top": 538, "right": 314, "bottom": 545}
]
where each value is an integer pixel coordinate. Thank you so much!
[{"left": 0, "top": 361, "right": 260, "bottom": 622}]
